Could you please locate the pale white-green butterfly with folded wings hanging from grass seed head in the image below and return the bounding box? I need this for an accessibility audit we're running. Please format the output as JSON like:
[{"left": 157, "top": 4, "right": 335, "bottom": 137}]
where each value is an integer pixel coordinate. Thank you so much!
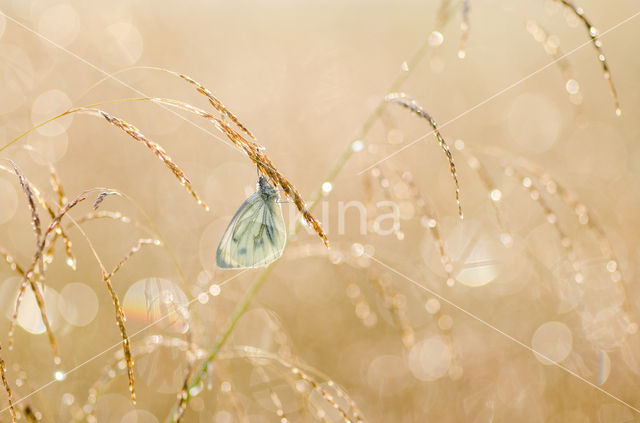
[{"left": 216, "top": 176, "right": 287, "bottom": 269}]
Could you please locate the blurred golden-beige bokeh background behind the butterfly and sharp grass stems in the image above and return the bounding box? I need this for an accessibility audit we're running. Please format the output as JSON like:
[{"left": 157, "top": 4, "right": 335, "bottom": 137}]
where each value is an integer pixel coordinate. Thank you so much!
[{"left": 0, "top": 0, "right": 640, "bottom": 423}]
